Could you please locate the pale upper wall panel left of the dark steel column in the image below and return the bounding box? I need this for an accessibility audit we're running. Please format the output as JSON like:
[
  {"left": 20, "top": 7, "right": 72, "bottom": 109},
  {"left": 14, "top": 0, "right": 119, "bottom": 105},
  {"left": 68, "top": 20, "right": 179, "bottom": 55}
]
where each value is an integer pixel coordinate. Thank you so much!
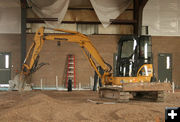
[{"left": 0, "top": 0, "right": 21, "bottom": 33}]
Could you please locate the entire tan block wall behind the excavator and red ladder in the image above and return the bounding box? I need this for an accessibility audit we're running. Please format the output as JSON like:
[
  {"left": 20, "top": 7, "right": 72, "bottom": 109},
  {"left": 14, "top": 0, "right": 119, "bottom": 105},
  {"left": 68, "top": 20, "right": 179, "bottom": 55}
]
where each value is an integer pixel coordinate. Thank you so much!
[{"left": 0, "top": 34, "right": 180, "bottom": 86}]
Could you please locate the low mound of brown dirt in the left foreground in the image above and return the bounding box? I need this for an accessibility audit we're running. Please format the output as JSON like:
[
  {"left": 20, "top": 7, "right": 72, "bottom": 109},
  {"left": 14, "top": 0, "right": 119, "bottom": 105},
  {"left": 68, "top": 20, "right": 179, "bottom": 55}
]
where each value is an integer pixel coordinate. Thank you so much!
[{"left": 0, "top": 93, "right": 89, "bottom": 122}]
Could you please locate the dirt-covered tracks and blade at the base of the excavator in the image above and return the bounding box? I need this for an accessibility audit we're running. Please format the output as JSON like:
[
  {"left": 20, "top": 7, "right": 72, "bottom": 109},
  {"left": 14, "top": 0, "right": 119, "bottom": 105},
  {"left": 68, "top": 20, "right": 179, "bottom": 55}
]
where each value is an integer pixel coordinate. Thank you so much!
[{"left": 99, "top": 83, "right": 171, "bottom": 102}]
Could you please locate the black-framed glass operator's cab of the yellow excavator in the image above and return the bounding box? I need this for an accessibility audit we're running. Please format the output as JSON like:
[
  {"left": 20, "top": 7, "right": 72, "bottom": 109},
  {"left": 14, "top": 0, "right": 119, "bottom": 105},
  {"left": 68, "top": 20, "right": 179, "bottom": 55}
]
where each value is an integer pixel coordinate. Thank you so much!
[{"left": 115, "top": 35, "right": 153, "bottom": 77}]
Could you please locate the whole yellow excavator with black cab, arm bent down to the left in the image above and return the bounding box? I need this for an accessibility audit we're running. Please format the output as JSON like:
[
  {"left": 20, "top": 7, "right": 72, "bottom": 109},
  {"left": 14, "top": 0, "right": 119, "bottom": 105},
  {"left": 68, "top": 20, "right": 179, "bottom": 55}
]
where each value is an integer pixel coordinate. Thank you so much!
[{"left": 8, "top": 27, "right": 171, "bottom": 102}]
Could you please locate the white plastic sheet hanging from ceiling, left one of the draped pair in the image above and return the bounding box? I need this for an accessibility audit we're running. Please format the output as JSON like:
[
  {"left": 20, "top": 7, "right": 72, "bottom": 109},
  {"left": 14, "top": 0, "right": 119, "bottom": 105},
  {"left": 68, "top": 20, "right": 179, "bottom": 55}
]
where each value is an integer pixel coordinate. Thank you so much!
[{"left": 29, "top": 0, "right": 69, "bottom": 27}]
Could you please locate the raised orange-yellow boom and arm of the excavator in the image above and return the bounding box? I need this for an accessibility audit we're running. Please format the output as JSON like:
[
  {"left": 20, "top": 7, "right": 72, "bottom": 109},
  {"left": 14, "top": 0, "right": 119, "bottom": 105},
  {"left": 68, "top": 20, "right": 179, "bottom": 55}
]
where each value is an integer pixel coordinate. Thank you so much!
[{"left": 22, "top": 27, "right": 112, "bottom": 84}]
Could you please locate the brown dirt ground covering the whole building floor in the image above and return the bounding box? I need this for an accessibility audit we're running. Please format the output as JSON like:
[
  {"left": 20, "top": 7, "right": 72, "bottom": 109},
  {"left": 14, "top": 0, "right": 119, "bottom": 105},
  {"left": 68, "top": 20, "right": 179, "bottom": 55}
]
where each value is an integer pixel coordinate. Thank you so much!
[{"left": 0, "top": 91, "right": 180, "bottom": 122}]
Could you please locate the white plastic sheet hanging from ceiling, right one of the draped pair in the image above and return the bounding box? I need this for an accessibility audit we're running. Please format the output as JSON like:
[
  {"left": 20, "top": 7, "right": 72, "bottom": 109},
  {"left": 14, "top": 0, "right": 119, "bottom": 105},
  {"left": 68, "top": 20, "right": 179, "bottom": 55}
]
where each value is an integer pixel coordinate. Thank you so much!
[{"left": 90, "top": 0, "right": 132, "bottom": 27}]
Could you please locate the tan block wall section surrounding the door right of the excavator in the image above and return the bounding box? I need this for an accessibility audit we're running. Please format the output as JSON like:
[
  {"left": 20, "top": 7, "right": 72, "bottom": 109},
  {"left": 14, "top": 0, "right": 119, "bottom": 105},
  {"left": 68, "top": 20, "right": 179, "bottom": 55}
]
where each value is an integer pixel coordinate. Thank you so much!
[{"left": 152, "top": 36, "right": 180, "bottom": 88}]
